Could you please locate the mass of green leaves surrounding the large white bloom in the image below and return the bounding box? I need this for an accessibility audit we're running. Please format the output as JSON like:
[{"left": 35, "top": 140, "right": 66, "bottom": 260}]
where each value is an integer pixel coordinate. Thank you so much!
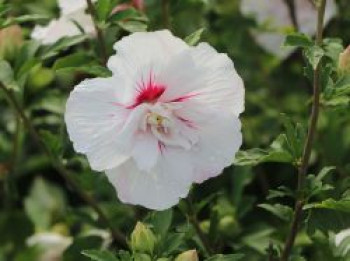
[{"left": 0, "top": 0, "right": 350, "bottom": 261}]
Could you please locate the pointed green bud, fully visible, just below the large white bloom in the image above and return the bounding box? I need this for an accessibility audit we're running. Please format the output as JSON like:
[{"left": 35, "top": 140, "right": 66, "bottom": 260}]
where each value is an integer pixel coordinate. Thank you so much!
[{"left": 131, "top": 222, "right": 156, "bottom": 254}]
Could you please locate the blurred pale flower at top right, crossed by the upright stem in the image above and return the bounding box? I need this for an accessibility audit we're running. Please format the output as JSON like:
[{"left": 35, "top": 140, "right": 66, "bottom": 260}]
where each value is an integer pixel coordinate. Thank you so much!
[{"left": 240, "top": 0, "right": 337, "bottom": 58}]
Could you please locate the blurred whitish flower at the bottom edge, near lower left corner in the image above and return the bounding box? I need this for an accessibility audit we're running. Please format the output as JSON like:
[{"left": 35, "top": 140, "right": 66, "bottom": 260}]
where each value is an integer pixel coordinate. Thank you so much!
[{"left": 27, "top": 232, "right": 73, "bottom": 261}]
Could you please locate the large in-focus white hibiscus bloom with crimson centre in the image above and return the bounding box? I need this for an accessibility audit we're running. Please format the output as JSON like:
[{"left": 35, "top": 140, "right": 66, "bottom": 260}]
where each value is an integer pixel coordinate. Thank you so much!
[{"left": 65, "top": 30, "right": 244, "bottom": 209}]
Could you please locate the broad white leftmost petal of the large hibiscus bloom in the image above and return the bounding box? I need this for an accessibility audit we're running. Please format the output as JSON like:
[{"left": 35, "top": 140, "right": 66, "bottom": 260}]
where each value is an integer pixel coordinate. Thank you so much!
[{"left": 65, "top": 78, "right": 129, "bottom": 170}]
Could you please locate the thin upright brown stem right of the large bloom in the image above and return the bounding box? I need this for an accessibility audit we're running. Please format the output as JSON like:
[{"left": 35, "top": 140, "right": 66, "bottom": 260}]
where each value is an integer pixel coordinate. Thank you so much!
[{"left": 281, "top": 0, "right": 326, "bottom": 261}]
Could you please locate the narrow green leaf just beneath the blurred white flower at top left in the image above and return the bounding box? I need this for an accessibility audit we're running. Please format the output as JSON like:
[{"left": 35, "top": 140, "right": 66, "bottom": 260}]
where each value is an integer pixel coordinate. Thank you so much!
[{"left": 41, "top": 35, "right": 87, "bottom": 59}]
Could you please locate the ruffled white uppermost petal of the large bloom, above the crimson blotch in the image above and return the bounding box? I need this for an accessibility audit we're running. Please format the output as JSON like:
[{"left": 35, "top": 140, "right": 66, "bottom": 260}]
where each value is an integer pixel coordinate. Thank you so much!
[{"left": 108, "top": 30, "right": 189, "bottom": 101}]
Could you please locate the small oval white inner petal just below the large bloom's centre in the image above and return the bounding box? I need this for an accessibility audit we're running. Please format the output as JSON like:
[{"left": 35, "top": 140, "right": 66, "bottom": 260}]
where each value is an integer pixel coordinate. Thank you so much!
[{"left": 132, "top": 133, "right": 160, "bottom": 171}]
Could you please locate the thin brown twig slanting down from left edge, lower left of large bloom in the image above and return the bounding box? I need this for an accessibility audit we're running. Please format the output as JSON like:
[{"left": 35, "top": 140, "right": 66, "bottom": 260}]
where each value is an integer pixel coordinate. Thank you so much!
[{"left": 0, "top": 84, "right": 127, "bottom": 247}]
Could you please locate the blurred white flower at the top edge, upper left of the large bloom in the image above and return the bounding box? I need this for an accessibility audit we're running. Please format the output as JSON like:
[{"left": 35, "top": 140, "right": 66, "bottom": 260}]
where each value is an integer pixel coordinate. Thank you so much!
[{"left": 31, "top": 0, "right": 95, "bottom": 44}]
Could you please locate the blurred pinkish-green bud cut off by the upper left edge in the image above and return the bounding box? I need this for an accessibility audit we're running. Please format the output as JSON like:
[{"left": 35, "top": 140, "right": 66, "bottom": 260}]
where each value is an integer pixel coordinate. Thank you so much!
[{"left": 0, "top": 25, "right": 23, "bottom": 60}]
